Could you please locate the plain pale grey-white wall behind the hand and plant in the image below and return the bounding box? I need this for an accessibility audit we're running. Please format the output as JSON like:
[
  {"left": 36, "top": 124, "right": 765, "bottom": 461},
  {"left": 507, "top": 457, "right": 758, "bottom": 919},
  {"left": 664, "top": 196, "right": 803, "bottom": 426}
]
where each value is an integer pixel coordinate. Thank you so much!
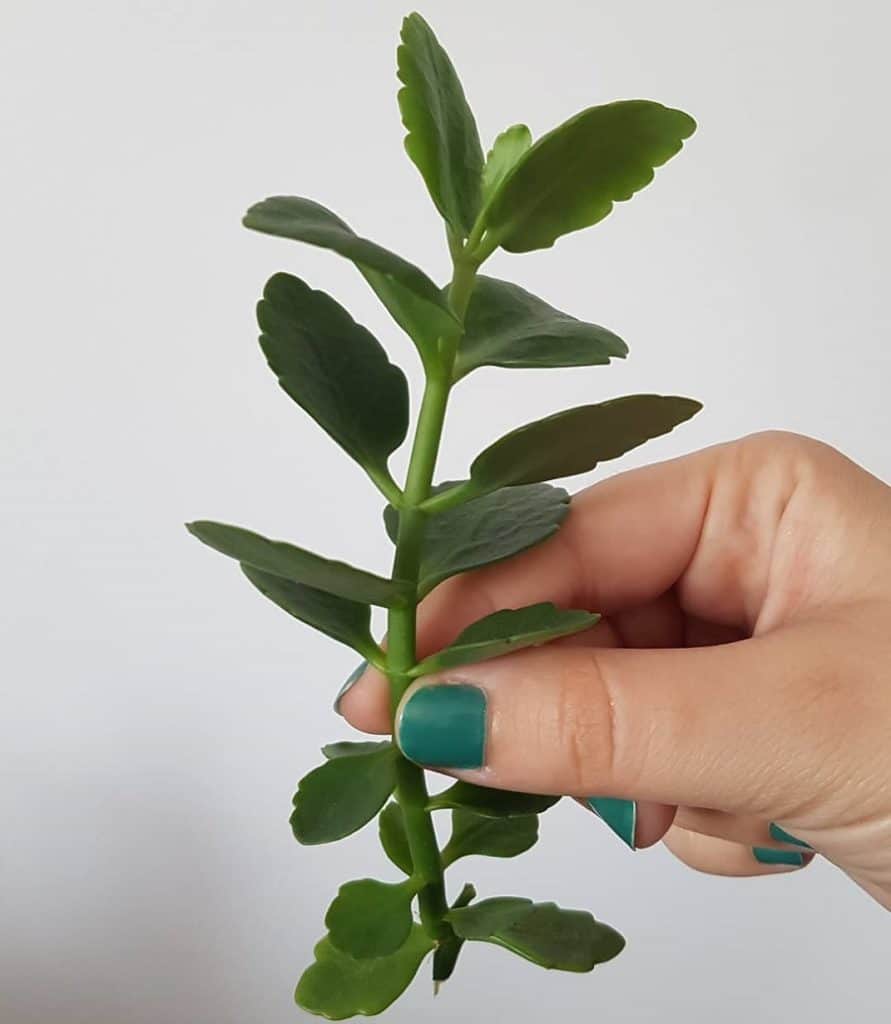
[{"left": 0, "top": 0, "right": 891, "bottom": 1024}]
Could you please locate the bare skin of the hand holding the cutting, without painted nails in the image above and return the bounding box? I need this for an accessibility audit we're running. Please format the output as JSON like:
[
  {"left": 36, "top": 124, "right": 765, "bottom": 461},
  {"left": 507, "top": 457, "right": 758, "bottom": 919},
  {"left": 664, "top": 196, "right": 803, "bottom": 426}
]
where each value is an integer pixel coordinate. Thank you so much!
[{"left": 341, "top": 433, "right": 891, "bottom": 908}]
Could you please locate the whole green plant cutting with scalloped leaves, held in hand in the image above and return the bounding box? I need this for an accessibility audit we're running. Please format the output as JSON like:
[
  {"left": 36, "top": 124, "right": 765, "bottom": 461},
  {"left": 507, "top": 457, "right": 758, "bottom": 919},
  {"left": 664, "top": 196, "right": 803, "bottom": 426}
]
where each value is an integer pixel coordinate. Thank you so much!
[{"left": 188, "top": 14, "right": 699, "bottom": 1020}]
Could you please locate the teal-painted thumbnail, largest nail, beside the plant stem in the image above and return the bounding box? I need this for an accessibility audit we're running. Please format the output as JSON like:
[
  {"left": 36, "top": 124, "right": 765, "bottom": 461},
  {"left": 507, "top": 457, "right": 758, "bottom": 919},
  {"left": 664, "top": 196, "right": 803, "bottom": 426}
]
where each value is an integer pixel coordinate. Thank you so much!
[{"left": 396, "top": 683, "right": 485, "bottom": 768}]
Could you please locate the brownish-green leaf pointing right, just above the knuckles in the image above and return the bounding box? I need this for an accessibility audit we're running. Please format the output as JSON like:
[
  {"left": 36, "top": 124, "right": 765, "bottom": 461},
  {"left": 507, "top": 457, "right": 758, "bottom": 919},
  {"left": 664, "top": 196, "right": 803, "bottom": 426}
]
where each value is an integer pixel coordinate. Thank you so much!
[{"left": 470, "top": 394, "right": 703, "bottom": 490}]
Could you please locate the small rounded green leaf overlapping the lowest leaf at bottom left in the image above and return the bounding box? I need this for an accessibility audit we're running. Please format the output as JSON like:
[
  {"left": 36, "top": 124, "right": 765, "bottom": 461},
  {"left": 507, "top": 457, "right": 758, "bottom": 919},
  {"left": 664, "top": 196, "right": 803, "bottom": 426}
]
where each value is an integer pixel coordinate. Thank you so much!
[{"left": 325, "top": 879, "right": 413, "bottom": 959}]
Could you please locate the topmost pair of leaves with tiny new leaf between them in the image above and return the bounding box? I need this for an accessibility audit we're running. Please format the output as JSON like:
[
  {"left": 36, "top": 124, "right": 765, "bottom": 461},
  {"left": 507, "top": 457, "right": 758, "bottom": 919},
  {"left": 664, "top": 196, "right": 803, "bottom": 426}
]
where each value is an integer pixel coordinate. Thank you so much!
[{"left": 397, "top": 13, "right": 696, "bottom": 252}]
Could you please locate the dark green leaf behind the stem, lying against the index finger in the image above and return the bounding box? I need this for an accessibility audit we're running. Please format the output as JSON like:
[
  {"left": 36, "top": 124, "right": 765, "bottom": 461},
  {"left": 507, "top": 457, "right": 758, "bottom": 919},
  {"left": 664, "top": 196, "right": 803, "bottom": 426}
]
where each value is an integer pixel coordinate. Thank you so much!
[{"left": 384, "top": 484, "right": 569, "bottom": 596}]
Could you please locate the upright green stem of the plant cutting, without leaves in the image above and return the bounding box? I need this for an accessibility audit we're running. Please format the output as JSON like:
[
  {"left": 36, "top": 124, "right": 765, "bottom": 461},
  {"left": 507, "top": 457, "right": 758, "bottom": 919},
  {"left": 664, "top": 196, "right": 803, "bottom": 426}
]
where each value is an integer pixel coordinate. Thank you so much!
[{"left": 387, "top": 247, "right": 477, "bottom": 942}]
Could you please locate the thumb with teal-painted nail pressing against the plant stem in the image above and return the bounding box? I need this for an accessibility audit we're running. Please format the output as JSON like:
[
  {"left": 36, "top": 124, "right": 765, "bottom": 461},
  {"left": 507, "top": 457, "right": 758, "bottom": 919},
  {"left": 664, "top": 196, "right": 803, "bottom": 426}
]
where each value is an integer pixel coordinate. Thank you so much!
[{"left": 395, "top": 626, "right": 842, "bottom": 827}]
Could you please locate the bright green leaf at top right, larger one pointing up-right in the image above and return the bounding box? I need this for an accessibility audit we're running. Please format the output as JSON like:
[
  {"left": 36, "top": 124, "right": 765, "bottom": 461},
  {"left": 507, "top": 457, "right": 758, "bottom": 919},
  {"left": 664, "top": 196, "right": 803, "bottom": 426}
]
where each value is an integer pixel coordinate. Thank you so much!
[{"left": 485, "top": 99, "right": 696, "bottom": 253}]
